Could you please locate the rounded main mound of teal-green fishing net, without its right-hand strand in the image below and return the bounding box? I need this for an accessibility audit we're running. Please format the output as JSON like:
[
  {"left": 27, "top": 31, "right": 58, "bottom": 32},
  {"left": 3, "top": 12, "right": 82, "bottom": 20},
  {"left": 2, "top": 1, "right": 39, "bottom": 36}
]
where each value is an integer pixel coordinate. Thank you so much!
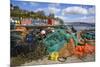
[{"left": 44, "top": 29, "right": 67, "bottom": 53}]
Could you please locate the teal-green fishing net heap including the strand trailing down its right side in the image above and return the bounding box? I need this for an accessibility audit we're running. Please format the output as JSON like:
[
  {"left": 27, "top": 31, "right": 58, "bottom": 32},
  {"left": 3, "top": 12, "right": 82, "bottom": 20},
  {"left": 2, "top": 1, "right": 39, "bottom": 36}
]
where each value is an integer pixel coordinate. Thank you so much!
[{"left": 43, "top": 29, "right": 78, "bottom": 53}]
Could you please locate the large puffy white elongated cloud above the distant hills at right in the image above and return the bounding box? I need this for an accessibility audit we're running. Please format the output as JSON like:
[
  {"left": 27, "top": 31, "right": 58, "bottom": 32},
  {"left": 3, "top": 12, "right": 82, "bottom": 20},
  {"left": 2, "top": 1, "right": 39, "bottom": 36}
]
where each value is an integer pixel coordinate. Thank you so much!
[{"left": 62, "top": 6, "right": 88, "bottom": 15}]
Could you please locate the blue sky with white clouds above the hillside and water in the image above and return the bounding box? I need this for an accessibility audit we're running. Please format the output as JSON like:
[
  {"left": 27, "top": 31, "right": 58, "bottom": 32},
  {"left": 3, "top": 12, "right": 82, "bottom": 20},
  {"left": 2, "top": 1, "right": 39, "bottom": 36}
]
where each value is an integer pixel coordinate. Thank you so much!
[{"left": 11, "top": 0, "right": 95, "bottom": 23}]
